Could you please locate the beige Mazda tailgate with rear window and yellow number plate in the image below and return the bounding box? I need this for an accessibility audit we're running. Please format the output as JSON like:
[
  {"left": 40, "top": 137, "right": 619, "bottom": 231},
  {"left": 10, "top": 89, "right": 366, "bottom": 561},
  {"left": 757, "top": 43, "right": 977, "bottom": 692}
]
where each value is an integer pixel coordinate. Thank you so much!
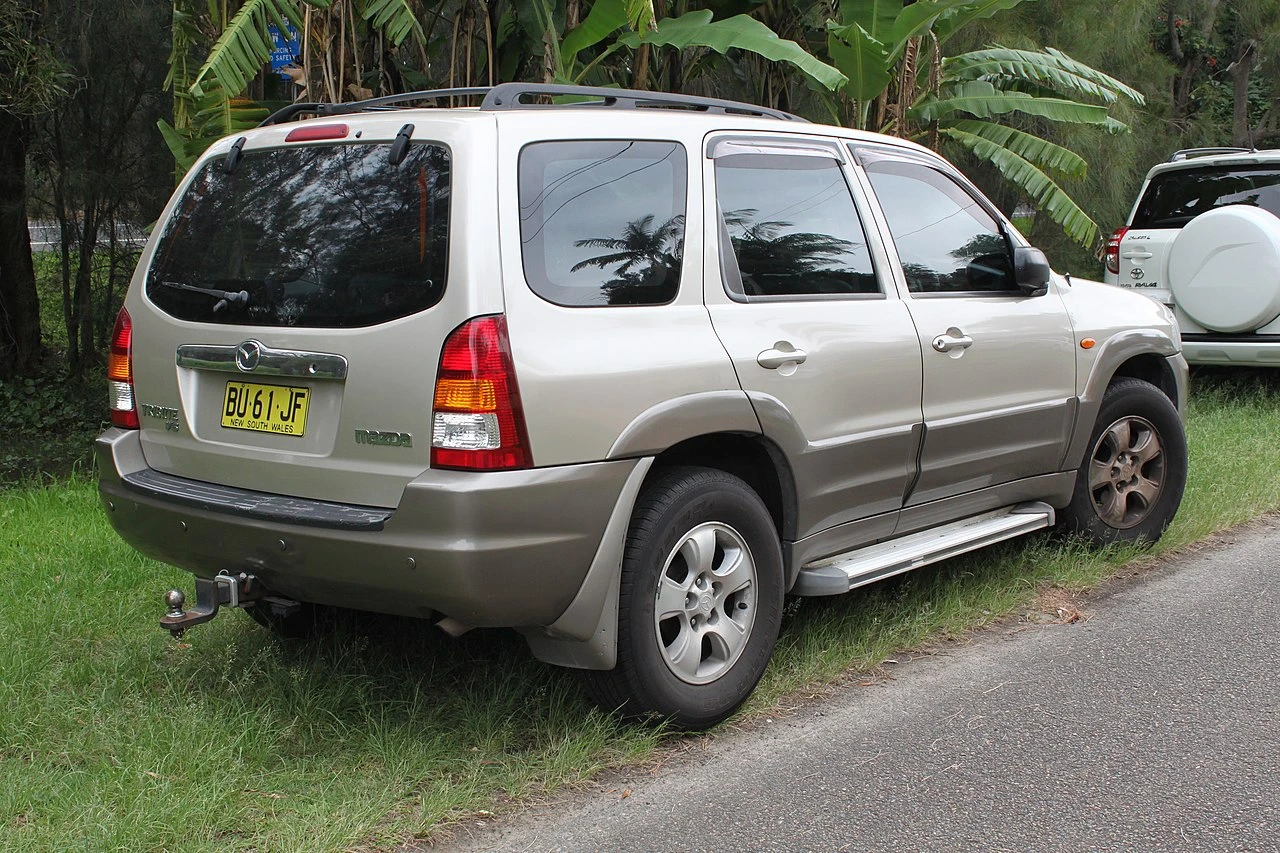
[{"left": 125, "top": 114, "right": 502, "bottom": 506}]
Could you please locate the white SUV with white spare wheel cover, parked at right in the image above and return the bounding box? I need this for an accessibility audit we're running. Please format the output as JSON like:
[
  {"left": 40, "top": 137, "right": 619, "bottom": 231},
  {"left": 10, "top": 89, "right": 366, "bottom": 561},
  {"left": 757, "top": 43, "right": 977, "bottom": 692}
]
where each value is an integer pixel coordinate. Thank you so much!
[{"left": 1105, "top": 149, "right": 1280, "bottom": 366}]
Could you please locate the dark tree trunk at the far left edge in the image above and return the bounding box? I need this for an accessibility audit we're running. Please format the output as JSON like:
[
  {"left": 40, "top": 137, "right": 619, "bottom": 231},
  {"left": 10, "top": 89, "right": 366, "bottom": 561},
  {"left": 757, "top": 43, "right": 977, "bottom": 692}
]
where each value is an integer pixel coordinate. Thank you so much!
[{"left": 0, "top": 110, "right": 40, "bottom": 379}]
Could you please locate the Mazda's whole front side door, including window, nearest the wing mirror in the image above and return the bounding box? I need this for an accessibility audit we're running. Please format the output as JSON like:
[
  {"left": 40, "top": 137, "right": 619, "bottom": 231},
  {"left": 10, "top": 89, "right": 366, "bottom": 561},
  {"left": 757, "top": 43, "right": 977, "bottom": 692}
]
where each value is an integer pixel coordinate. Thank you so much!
[{"left": 859, "top": 150, "right": 1076, "bottom": 506}]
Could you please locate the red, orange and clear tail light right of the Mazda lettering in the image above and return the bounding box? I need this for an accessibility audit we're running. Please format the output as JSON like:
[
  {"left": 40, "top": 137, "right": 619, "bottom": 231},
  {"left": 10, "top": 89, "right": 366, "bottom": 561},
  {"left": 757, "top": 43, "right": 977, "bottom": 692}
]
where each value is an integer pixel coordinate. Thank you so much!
[{"left": 431, "top": 314, "right": 534, "bottom": 471}]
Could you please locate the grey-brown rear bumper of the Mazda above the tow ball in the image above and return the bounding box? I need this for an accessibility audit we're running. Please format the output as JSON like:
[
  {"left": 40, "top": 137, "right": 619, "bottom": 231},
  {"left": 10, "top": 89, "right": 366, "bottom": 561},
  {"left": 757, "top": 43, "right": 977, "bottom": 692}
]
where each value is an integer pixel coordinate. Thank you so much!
[{"left": 96, "top": 429, "right": 637, "bottom": 628}]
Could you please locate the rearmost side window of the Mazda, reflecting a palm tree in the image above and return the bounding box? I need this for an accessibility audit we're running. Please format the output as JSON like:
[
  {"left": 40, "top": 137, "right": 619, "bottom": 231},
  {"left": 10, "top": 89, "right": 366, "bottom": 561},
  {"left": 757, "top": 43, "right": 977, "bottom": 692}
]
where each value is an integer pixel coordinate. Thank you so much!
[{"left": 520, "top": 141, "right": 687, "bottom": 306}]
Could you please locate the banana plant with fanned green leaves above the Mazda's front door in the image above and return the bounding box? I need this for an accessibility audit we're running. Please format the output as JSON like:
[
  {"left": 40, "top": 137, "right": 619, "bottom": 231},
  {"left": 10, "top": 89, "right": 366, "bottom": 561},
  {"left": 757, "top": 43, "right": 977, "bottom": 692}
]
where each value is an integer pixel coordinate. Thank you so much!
[{"left": 826, "top": 0, "right": 1143, "bottom": 246}]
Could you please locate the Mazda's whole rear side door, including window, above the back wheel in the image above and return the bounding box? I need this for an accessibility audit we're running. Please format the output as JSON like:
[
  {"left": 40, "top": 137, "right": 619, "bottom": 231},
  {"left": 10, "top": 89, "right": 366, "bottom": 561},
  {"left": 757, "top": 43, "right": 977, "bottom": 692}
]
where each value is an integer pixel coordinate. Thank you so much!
[{"left": 704, "top": 134, "right": 920, "bottom": 538}]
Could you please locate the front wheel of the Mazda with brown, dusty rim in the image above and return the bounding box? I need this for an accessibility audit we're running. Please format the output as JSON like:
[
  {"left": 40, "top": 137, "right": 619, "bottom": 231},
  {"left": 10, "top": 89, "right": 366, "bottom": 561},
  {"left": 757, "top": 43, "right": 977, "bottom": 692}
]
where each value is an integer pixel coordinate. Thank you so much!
[{"left": 1059, "top": 378, "right": 1187, "bottom": 544}]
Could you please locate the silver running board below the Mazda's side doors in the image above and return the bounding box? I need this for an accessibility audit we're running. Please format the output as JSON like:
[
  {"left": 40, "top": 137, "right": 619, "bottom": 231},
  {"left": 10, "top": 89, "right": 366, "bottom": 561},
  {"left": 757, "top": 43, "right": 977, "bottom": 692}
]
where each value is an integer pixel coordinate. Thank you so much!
[{"left": 791, "top": 501, "right": 1053, "bottom": 596}]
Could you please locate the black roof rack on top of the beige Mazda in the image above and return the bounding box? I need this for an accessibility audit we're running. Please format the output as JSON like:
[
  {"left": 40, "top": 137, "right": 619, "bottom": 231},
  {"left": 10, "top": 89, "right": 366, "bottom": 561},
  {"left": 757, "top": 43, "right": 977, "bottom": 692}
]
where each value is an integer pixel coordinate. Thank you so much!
[{"left": 259, "top": 83, "right": 806, "bottom": 127}]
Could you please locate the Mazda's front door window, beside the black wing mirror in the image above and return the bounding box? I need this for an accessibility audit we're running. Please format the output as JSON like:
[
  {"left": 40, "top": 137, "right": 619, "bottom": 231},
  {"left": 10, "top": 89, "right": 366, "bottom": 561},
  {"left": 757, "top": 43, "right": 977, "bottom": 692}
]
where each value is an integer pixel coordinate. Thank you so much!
[{"left": 867, "top": 160, "right": 1018, "bottom": 293}]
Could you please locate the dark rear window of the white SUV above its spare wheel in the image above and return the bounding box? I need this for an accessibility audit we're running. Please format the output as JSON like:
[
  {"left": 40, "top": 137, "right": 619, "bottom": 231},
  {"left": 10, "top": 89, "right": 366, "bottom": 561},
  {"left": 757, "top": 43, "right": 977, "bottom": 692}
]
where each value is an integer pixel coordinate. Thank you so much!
[{"left": 1130, "top": 165, "right": 1280, "bottom": 228}]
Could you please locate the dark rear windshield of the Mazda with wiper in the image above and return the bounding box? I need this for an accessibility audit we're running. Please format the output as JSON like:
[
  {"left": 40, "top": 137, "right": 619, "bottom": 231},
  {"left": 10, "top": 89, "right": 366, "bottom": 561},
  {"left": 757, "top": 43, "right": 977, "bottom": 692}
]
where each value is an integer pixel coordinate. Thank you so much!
[{"left": 146, "top": 143, "right": 449, "bottom": 328}]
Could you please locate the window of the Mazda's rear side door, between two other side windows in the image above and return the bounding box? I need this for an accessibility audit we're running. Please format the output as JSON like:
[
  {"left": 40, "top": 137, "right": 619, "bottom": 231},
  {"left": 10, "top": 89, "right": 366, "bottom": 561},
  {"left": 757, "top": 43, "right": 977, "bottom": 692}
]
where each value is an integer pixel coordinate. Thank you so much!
[{"left": 716, "top": 154, "right": 881, "bottom": 297}]
